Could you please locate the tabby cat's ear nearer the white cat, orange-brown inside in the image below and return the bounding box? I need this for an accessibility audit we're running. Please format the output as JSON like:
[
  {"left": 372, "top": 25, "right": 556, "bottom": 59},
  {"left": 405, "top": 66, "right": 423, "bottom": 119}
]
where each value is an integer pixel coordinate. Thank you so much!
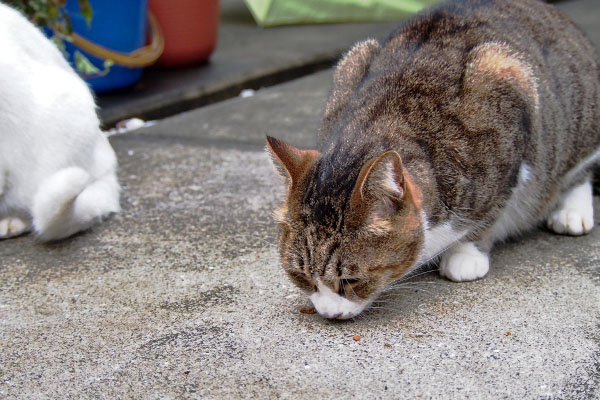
[{"left": 267, "top": 136, "right": 320, "bottom": 186}]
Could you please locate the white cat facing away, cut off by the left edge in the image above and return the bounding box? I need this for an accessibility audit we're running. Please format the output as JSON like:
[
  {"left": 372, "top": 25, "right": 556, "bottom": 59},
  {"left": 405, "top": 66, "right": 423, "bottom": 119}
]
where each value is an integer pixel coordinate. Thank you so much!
[{"left": 0, "top": 3, "right": 120, "bottom": 241}]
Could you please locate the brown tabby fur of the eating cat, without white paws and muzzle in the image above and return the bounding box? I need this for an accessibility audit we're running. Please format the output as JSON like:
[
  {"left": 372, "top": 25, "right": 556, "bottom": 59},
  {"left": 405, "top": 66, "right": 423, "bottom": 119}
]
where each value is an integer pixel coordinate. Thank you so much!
[{"left": 268, "top": 0, "right": 600, "bottom": 318}]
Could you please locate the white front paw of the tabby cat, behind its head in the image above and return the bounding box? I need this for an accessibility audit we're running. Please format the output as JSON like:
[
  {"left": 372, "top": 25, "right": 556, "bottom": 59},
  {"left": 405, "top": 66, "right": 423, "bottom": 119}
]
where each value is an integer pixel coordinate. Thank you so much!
[{"left": 440, "top": 242, "right": 490, "bottom": 282}]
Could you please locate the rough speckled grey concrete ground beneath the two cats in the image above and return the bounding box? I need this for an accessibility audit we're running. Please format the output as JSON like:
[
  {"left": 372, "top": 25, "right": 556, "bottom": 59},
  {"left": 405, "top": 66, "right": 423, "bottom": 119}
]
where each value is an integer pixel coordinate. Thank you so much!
[{"left": 0, "top": 0, "right": 600, "bottom": 399}]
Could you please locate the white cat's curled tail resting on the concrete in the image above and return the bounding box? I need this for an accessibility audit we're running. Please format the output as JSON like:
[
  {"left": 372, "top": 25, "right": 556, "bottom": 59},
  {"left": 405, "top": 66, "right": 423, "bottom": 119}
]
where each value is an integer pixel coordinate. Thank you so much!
[{"left": 32, "top": 167, "right": 120, "bottom": 241}]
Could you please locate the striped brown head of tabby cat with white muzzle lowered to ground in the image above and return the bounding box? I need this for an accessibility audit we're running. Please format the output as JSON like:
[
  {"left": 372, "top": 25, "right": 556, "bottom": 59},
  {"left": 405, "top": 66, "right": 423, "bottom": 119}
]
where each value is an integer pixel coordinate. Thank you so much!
[{"left": 267, "top": 137, "right": 424, "bottom": 319}]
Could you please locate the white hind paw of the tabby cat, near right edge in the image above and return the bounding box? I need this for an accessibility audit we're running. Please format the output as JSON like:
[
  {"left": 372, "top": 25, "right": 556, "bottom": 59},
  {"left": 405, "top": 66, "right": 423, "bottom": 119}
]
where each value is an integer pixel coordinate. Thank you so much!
[{"left": 547, "top": 180, "right": 594, "bottom": 235}]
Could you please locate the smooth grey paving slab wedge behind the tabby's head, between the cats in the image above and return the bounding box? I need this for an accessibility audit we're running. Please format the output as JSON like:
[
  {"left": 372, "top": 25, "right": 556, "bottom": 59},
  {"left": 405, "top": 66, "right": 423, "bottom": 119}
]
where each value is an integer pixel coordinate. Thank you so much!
[{"left": 134, "top": 70, "right": 332, "bottom": 148}]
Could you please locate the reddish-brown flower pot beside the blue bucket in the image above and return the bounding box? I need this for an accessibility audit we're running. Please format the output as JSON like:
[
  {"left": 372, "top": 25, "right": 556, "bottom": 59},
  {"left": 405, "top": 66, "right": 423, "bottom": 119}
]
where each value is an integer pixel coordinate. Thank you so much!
[{"left": 148, "top": 0, "right": 219, "bottom": 67}]
